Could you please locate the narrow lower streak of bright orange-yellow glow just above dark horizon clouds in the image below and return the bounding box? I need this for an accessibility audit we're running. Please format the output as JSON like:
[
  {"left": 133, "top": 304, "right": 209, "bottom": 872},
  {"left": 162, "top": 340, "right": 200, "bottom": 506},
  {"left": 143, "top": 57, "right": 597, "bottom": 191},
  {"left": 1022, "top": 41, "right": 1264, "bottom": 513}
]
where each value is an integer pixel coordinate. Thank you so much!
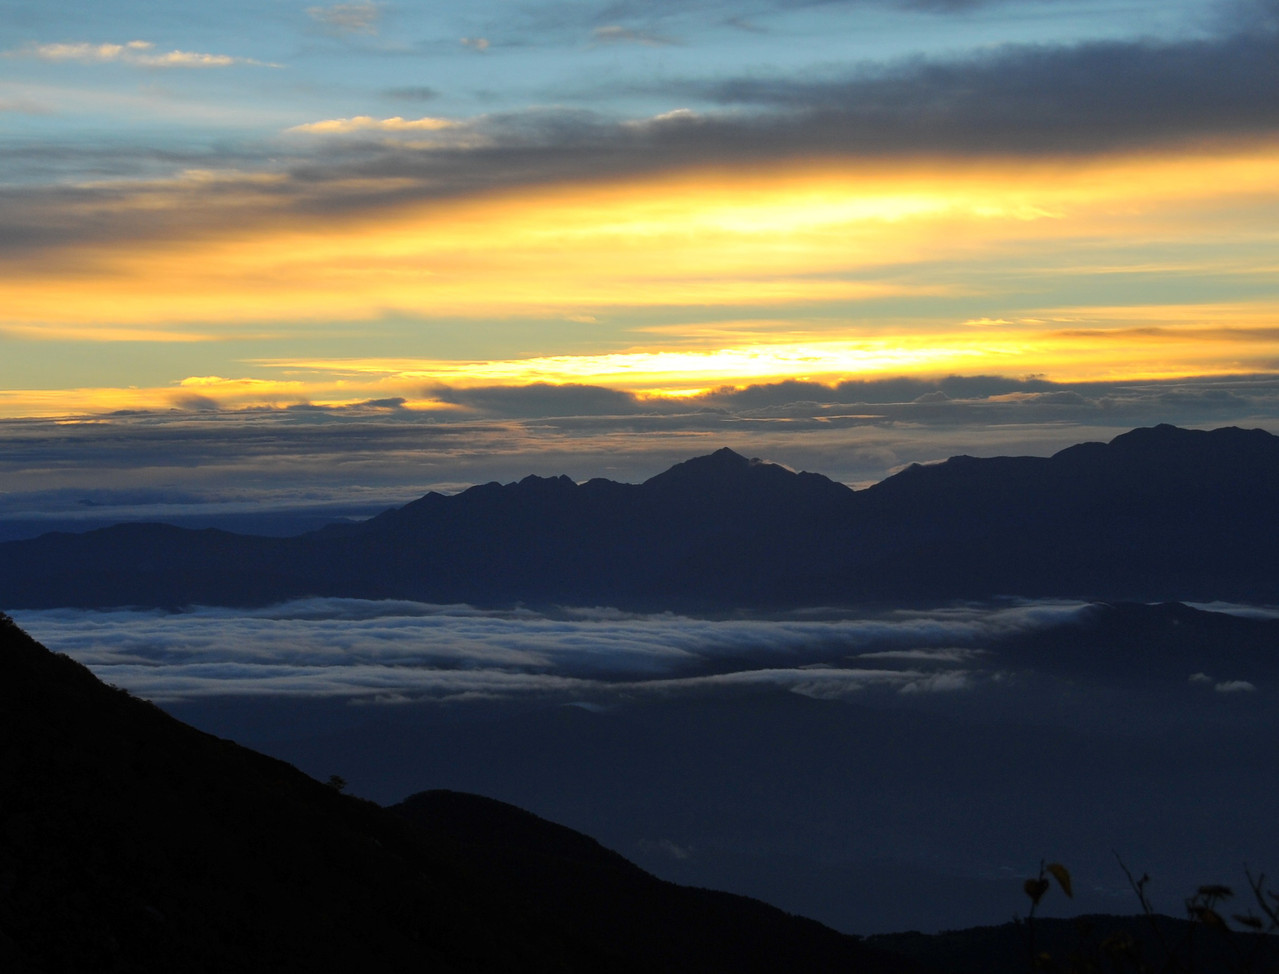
[{"left": 0, "top": 318, "right": 1279, "bottom": 417}]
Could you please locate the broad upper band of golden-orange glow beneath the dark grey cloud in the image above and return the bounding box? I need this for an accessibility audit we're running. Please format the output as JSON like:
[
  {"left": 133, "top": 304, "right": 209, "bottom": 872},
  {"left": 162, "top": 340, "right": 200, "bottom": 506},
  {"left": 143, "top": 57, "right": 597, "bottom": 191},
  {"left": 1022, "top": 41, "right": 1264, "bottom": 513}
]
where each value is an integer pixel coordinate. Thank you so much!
[{"left": 7, "top": 142, "right": 1279, "bottom": 329}]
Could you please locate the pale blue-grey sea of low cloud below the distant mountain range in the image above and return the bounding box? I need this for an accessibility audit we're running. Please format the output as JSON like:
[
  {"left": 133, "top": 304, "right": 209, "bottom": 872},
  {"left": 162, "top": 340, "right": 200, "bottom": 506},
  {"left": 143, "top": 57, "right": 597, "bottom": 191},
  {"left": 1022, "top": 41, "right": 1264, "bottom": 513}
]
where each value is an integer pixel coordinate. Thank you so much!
[{"left": 14, "top": 598, "right": 1083, "bottom": 703}]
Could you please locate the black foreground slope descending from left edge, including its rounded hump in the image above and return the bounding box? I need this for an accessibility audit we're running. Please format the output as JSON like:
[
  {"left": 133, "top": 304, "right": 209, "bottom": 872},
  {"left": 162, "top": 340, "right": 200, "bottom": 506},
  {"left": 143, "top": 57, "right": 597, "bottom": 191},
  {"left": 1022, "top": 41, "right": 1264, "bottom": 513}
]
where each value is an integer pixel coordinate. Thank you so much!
[{"left": 0, "top": 616, "right": 903, "bottom": 971}]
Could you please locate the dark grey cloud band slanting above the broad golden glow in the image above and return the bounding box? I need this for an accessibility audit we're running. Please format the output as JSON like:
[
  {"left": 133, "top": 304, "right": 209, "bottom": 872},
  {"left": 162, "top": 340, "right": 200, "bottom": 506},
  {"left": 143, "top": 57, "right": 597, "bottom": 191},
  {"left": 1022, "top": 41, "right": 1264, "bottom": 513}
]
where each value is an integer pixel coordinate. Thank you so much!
[{"left": 0, "top": 11, "right": 1279, "bottom": 254}]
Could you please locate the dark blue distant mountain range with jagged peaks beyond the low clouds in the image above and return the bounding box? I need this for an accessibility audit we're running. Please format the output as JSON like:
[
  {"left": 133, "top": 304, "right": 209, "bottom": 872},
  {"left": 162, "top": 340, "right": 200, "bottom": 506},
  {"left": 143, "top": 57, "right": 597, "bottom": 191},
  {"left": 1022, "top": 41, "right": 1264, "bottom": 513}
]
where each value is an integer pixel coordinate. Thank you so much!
[{"left": 0, "top": 426, "right": 1279, "bottom": 611}]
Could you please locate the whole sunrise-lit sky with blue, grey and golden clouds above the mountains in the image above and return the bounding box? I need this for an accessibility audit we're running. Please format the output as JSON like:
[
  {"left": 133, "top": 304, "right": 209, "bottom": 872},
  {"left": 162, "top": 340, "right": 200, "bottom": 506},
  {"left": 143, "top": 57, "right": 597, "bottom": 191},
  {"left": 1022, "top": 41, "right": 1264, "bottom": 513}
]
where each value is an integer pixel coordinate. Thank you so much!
[{"left": 0, "top": 0, "right": 1279, "bottom": 519}]
